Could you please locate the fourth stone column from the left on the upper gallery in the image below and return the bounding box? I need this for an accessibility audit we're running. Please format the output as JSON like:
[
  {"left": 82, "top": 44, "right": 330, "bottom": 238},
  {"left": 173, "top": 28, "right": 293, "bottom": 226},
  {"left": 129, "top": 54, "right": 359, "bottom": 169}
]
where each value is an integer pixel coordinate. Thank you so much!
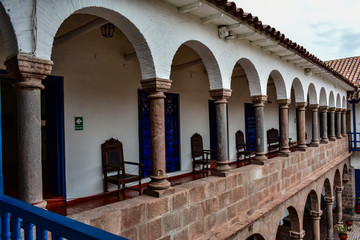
[{"left": 250, "top": 95, "right": 267, "bottom": 164}]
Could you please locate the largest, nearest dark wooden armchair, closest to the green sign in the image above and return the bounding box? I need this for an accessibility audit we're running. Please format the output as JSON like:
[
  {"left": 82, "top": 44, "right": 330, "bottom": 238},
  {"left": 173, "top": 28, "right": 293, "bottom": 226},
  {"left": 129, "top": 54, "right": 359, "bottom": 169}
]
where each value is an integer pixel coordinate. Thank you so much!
[{"left": 101, "top": 138, "right": 143, "bottom": 198}]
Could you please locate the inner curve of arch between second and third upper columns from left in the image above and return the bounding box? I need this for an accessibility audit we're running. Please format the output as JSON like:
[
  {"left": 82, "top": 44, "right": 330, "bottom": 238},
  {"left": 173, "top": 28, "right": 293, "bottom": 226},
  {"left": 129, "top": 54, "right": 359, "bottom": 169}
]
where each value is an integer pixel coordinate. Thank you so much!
[{"left": 179, "top": 40, "right": 223, "bottom": 89}]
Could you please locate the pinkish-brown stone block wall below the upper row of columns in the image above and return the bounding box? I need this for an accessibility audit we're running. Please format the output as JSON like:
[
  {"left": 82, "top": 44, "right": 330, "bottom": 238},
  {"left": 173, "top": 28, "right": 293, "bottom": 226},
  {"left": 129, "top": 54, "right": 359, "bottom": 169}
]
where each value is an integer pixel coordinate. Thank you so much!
[{"left": 71, "top": 139, "right": 348, "bottom": 239}]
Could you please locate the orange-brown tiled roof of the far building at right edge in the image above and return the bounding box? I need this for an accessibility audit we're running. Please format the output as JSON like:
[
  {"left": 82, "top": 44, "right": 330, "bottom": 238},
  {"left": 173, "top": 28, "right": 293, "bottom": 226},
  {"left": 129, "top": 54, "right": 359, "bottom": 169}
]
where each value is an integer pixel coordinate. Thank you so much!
[{"left": 325, "top": 56, "right": 360, "bottom": 85}]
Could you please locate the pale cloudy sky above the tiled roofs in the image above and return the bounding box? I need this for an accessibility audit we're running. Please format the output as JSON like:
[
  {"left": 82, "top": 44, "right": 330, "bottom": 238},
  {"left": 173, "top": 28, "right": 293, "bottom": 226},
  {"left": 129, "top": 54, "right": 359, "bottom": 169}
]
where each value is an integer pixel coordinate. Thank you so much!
[{"left": 232, "top": 0, "right": 360, "bottom": 61}]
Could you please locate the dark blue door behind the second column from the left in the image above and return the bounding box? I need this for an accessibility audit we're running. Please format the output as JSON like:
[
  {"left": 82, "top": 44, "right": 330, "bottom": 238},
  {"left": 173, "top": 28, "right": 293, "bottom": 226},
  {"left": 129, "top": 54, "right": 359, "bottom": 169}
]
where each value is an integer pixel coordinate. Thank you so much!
[{"left": 138, "top": 89, "right": 180, "bottom": 177}]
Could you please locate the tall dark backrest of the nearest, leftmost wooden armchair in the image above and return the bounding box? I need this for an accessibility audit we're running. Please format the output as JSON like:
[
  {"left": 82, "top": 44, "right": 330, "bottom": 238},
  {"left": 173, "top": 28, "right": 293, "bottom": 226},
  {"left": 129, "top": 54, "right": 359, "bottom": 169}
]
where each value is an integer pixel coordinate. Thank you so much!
[{"left": 101, "top": 138, "right": 125, "bottom": 174}]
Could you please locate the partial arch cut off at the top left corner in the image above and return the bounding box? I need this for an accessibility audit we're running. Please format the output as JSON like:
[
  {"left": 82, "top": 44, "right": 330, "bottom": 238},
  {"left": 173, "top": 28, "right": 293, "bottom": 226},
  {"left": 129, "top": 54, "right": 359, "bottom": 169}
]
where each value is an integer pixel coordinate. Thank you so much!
[{"left": 0, "top": 2, "right": 19, "bottom": 59}]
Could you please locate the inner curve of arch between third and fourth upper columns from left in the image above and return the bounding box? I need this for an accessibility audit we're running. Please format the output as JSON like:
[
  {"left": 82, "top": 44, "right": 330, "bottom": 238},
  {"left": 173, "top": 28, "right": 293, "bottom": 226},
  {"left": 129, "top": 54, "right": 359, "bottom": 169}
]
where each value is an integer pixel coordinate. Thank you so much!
[{"left": 238, "top": 58, "right": 262, "bottom": 96}]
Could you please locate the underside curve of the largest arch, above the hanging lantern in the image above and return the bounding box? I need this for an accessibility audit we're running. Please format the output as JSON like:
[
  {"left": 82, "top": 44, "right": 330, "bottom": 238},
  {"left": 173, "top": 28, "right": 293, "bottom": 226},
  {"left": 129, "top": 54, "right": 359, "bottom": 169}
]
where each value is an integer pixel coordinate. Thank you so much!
[{"left": 49, "top": 7, "right": 156, "bottom": 79}]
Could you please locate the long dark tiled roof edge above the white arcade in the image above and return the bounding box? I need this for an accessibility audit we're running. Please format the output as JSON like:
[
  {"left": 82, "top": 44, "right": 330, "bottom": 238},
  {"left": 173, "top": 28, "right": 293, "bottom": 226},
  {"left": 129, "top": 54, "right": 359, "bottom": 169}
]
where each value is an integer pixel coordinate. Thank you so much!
[{"left": 207, "top": 0, "right": 357, "bottom": 88}]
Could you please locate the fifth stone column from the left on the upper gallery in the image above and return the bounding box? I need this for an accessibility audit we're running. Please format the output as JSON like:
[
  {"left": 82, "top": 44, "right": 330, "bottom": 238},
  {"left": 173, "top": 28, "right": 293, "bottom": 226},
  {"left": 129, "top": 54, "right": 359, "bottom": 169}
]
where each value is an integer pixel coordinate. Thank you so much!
[{"left": 278, "top": 99, "right": 291, "bottom": 157}]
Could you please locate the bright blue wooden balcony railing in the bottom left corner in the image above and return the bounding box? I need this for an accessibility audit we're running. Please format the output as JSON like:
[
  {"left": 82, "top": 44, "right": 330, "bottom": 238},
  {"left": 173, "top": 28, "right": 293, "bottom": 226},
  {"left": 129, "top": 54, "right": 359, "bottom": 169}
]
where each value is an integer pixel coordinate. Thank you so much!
[{"left": 0, "top": 195, "right": 125, "bottom": 240}]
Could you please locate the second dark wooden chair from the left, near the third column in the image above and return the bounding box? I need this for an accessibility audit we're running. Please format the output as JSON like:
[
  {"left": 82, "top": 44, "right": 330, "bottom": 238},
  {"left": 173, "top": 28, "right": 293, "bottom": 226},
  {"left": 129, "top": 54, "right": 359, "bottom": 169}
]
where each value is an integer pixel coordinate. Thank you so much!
[{"left": 191, "top": 133, "right": 216, "bottom": 176}]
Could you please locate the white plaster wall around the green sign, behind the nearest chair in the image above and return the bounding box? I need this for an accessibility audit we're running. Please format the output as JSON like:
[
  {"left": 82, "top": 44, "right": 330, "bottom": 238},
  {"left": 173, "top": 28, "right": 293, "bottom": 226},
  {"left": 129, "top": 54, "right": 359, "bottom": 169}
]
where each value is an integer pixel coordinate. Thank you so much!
[{"left": 52, "top": 27, "right": 141, "bottom": 200}]
